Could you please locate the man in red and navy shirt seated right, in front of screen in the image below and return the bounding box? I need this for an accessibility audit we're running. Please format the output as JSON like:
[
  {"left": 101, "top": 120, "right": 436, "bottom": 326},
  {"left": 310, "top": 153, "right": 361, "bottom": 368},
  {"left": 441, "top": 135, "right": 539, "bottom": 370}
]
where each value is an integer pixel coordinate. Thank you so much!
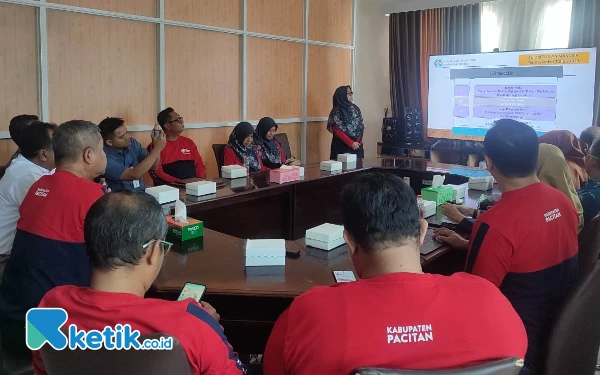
[{"left": 436, "top": 120, "right": 579, "bottom": 374}]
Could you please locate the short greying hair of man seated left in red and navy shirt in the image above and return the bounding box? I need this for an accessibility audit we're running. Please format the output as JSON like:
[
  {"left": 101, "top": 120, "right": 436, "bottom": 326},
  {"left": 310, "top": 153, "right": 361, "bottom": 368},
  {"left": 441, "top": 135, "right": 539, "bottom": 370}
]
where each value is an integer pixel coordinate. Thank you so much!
[{"left": 52, "top": 120, "right": 100, "bottom": 165}]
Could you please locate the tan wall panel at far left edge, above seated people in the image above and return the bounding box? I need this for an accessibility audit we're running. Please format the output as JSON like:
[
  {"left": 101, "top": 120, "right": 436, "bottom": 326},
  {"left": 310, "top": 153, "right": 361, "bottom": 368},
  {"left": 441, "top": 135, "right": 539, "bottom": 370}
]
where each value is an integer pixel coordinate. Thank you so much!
[{"left": 0, "top": 4, "right": 39, "bottom": 132}]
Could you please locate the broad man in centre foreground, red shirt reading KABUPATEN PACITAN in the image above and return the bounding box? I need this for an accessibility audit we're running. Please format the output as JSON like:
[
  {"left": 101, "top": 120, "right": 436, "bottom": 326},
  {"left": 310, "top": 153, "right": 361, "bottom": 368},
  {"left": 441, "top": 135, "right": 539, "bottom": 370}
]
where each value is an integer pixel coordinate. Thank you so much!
[{"left": 264, "top": 173, "right": 527, "bottom": 375}]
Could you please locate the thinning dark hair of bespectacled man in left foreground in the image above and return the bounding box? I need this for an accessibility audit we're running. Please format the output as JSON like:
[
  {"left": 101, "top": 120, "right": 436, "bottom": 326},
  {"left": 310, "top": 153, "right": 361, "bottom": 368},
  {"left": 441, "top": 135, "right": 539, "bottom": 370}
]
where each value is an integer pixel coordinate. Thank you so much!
[{"left": 83, "top": 191, "right": 167, "bottom": 271}]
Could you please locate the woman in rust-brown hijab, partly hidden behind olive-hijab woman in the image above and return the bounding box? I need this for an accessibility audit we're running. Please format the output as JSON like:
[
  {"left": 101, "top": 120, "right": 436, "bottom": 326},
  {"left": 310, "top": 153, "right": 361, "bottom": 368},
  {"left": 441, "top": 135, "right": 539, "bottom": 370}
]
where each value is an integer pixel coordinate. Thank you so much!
[{"left": 540, "top": 130, "right": 588, "bottom": 190}]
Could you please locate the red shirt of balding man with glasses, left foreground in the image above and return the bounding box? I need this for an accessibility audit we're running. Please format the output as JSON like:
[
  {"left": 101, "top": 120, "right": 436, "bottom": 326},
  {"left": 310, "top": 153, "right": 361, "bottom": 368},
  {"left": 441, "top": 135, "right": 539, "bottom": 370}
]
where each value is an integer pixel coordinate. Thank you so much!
[{"left": 33, "top": 286, "right": 246, "bottom": 375}]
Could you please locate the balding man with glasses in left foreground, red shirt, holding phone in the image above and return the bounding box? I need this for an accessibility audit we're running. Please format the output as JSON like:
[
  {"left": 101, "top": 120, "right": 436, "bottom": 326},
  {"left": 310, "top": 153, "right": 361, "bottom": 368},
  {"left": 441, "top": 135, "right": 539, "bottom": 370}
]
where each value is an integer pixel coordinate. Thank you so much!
[{"left": 33, "top": 191, "right": 246, "bottom": 375}]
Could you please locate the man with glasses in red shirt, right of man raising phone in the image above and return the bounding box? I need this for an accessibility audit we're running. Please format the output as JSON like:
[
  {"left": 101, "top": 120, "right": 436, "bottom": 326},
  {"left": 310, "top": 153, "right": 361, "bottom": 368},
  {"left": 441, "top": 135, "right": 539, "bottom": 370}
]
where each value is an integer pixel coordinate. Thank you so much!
[{"left": 149, "top": 107, "right": 206, "bottom": 183}]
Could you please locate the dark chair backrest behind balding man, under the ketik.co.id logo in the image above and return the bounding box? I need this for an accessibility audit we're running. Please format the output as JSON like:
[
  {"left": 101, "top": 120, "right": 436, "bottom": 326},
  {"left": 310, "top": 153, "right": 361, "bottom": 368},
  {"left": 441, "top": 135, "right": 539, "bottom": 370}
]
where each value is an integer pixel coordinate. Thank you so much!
[{"left": 41, "top": 333, "right": 192, "bottom": 375}]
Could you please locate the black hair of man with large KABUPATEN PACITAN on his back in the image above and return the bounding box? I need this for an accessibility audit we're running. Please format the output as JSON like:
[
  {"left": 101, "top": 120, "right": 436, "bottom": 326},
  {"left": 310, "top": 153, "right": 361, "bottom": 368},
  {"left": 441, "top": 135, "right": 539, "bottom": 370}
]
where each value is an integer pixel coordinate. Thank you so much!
[{"left": 341, "top": 172, "right": 421, "bottom": 253}]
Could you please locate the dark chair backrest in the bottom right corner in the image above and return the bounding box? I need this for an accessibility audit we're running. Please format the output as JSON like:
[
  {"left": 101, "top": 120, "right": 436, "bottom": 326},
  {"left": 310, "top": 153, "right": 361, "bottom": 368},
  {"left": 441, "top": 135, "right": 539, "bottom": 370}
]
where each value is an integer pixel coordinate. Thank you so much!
[{"left": 544, "top": 261, "right": 600, "bottom": 375}]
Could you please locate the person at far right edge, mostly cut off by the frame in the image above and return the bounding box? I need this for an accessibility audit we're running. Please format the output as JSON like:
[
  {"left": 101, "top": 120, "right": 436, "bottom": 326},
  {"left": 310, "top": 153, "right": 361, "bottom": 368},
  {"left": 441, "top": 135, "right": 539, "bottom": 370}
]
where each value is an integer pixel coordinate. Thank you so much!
[{"left": 577, "top": 140, "right": 600, "bottom": 224}]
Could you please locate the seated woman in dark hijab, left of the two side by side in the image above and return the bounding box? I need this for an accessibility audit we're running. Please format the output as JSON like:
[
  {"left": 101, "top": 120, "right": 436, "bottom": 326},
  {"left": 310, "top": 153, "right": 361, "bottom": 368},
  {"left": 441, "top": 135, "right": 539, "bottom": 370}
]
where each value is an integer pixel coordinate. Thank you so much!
[{"left": 223, "top": 121, "right": 267, "bottom": 172}]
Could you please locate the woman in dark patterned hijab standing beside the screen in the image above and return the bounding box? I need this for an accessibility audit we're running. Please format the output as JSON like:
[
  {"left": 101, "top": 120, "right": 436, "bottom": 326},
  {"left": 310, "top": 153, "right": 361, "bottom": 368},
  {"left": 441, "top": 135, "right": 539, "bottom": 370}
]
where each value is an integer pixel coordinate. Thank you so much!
[{"left": 327, "top": 86, "right": 365, "bottom": 160}]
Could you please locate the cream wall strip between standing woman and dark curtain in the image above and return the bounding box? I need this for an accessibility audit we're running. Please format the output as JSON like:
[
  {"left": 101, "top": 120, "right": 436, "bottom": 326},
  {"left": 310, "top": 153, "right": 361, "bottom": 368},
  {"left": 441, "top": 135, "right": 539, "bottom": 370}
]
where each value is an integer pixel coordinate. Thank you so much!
[{"left": 353, "top": 0, "right": 390, "bottom": 159}]
